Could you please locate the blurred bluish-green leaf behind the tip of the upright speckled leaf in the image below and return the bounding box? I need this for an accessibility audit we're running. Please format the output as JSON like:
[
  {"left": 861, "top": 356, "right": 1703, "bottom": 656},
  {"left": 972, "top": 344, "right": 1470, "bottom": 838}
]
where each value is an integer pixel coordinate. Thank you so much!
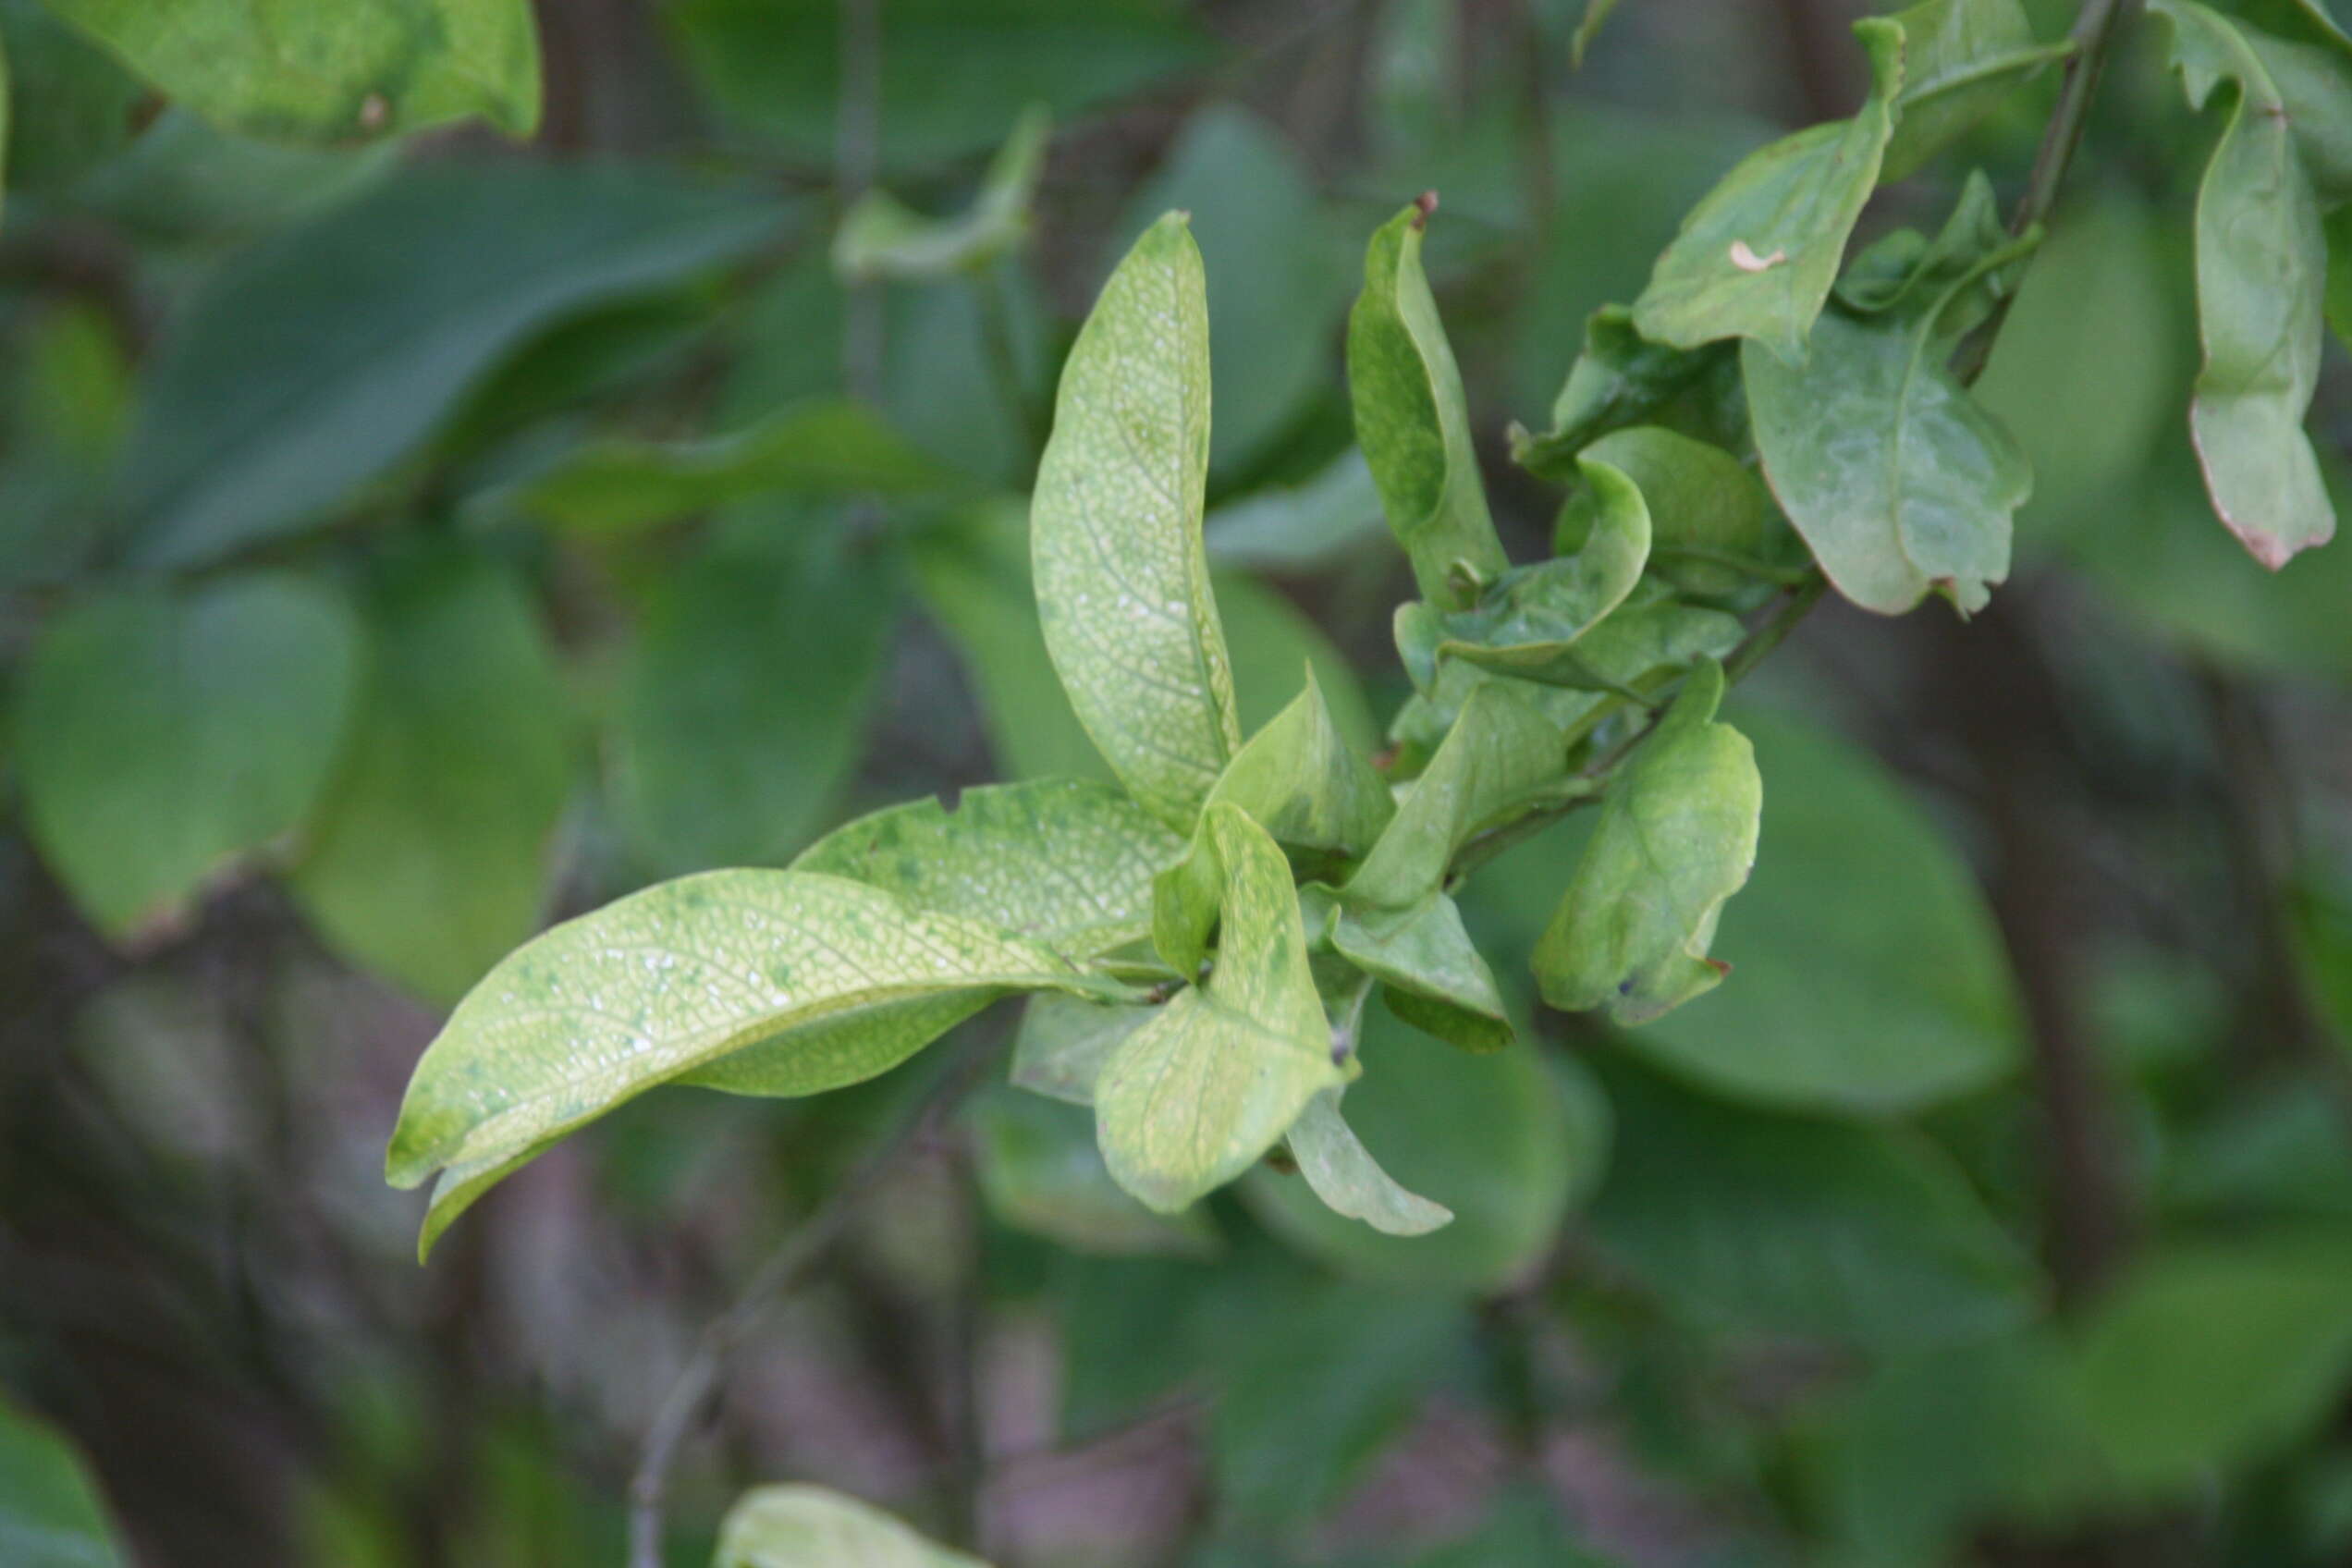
[{"left": 1124, "top": 96, "right": 1348, "bottom": 475}]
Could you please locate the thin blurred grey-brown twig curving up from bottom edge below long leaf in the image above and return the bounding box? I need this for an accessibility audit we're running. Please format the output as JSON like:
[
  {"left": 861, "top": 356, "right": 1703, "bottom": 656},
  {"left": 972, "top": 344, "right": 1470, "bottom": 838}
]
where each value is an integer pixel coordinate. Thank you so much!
[{"left": 628, "top": 1035, "right": 998, "bottom": 1568}]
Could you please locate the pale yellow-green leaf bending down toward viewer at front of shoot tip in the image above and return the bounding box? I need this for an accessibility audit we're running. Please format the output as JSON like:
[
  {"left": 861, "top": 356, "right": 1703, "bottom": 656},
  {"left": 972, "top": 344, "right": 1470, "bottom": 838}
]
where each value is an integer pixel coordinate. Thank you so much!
[{"left": 1094, "top": 804, "right": 1343, "bottom": 1213}]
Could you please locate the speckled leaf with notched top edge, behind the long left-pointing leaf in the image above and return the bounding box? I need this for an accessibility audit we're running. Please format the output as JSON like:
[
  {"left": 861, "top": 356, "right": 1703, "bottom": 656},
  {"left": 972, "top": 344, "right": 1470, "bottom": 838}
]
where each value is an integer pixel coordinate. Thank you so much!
[{"left": 792, "top": 778, "right": 1183, "bottom": 959}]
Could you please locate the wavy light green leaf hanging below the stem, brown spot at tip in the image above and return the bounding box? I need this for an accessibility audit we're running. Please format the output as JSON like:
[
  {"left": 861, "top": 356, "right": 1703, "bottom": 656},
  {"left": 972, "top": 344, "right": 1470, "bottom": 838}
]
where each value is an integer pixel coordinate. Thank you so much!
[{"left": 1536, "top": 661, "right": 1764, "bottom": 1023}]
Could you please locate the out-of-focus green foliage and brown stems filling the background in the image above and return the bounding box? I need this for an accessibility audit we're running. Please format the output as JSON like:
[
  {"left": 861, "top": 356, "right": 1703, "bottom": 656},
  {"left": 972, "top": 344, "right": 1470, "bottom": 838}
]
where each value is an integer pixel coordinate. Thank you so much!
[{"left": 13, "top": 0, "right": 2352, "bottom": 1568}]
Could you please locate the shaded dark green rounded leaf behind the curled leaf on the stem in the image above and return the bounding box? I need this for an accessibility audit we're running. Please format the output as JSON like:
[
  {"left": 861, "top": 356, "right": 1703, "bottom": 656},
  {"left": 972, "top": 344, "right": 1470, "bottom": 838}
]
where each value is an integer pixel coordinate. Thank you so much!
[{"left": 1552, "top": 425, "right": 1790, "bottom": 597}]
